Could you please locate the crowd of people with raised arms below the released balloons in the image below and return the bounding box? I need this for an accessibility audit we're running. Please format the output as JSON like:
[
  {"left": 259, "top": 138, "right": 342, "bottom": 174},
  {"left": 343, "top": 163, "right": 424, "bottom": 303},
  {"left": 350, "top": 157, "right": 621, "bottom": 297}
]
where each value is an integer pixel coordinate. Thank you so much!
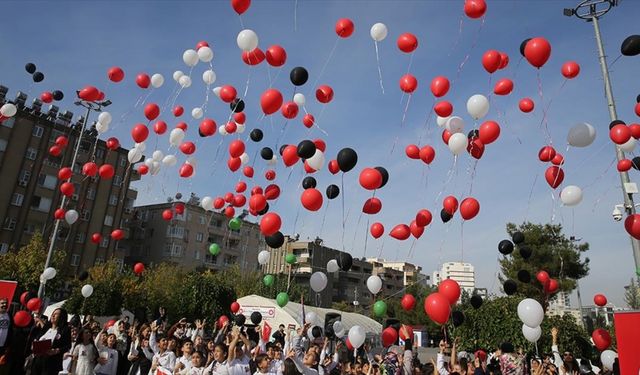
[{"left": 0, "top": 300, "right": 619, "bottom": 375}]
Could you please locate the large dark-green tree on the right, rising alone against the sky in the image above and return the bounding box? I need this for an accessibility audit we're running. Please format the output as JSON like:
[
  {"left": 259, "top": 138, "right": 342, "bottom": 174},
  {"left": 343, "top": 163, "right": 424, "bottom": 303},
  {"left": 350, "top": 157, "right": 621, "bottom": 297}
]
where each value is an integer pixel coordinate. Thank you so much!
[{"left": 500, "top": 223, "right": 589, "bottom": 310}]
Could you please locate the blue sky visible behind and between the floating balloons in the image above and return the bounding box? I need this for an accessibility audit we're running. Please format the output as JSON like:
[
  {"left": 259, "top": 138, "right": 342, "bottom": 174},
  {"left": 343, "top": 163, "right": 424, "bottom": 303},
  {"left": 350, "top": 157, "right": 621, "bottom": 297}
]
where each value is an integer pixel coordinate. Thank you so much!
[{"left": 0, "top": 0, "right": 640, "bottom": 305}]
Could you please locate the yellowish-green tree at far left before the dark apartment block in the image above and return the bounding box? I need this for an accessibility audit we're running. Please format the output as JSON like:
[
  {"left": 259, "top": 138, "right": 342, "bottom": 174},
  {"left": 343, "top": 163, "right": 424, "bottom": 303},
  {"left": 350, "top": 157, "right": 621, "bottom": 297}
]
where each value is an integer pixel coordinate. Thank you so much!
[{"left": 0, "top": 232, "right": 65, "bottom": 295}]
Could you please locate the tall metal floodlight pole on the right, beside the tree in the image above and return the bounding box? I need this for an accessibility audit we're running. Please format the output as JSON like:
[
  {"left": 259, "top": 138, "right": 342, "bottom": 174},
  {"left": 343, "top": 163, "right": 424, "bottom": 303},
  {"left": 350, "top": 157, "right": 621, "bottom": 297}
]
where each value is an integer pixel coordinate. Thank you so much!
[{"left": 564, "top": 0, "right": 640, "bottom": 273}]
